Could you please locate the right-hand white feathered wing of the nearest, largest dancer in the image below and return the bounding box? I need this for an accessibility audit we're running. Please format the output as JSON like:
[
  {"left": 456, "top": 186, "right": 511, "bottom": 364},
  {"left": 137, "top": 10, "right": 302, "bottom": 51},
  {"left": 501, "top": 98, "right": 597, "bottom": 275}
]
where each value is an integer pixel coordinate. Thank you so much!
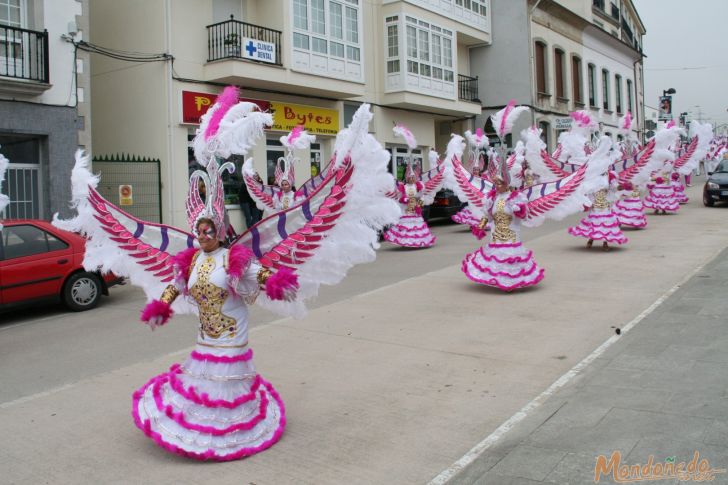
[{"left": 236, "top": 104, "right": 400, "bottom": 317}]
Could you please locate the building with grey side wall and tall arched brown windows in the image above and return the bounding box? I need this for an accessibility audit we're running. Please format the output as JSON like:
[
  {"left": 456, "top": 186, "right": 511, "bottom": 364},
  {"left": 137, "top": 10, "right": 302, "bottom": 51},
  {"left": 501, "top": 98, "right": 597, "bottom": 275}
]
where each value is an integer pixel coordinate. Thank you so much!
[{"left": 470, "top": 0, "right": 645, "bottom": 149}]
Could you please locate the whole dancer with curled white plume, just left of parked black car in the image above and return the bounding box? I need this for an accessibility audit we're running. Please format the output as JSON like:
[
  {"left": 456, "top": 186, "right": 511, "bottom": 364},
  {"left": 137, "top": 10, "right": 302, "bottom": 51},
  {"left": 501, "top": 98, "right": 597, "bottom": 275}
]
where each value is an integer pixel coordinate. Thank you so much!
[{"left": 384, "top": 125, "right": 437, "bottom": 248}]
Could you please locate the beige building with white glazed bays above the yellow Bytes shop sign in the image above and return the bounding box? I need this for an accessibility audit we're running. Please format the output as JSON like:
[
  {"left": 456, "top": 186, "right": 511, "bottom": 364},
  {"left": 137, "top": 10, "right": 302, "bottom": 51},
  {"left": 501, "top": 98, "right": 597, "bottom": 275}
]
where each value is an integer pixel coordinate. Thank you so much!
[{"left": 91, "top": 0, "right": 491, "bottom": 230}]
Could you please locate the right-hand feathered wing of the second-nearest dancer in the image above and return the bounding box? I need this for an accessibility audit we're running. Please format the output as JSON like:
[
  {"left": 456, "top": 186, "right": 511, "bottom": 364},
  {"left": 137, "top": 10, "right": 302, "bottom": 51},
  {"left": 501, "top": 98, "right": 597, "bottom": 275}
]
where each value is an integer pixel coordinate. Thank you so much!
[{"left": 521, "top": 137, "right": 612, "bottom": 227}]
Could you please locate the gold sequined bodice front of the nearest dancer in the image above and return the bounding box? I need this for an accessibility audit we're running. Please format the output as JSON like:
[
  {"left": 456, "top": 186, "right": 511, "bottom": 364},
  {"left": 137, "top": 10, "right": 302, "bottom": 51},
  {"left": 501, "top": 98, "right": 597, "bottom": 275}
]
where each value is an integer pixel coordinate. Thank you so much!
[{"left": 190, "top": 253, "right": 236, "bottom": 339}]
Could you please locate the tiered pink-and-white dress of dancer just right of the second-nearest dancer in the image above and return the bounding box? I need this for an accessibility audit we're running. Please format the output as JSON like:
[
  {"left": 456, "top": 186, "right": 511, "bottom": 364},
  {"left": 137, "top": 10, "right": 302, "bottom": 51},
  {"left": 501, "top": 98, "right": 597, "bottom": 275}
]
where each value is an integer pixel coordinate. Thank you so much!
[{"left": 569, "top": 173, "right": 627, "bottom": 244}]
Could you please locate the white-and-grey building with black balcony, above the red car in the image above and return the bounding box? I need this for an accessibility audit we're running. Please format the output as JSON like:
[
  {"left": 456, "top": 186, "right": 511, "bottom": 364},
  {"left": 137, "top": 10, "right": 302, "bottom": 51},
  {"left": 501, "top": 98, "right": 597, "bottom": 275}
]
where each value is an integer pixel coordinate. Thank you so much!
[{"left": 0, "top": 0, "right": 91, "bottom": 219}]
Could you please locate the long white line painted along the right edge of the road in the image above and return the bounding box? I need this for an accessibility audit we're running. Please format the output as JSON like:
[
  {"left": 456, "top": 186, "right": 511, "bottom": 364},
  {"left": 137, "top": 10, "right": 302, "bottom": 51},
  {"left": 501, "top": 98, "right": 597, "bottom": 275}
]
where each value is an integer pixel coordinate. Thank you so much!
[{"left": 429, "top": 248, "right": 725, "bottom": 485}]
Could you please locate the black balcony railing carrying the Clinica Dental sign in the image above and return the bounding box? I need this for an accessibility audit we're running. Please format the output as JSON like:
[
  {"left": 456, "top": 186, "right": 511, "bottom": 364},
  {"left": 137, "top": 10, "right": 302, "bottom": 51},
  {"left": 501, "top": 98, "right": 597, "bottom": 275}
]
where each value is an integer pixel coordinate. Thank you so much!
[{"left": 207, "top": 15, "right": 283, "bottom": 66}]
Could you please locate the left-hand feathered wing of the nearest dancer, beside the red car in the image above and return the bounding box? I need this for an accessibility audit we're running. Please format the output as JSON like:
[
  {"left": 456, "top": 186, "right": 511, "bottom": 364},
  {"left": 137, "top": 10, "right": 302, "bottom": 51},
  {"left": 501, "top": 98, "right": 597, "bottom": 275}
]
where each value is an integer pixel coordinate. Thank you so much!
[{"left": 53, "top": 150, "right": 195, "bottom": 313}]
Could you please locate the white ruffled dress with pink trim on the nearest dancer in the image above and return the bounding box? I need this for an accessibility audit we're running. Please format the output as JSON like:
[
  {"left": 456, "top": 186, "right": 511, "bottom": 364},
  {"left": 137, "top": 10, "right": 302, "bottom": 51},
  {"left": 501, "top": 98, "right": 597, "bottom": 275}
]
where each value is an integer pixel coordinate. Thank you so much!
[{"left": 132, "top": 248, "right": 286, "bottom": 461}]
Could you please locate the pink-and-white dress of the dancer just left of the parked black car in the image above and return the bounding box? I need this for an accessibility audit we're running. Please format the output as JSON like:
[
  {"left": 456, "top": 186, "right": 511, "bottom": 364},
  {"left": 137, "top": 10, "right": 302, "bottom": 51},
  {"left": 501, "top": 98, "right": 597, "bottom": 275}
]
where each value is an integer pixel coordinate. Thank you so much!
[{"left": 384, "top": 182, "right": 437, "bottom": 248}]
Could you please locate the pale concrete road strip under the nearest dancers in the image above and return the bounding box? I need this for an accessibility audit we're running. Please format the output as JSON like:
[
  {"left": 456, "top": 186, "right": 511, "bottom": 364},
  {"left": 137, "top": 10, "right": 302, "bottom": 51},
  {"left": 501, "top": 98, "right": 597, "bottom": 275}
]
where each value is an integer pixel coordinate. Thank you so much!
[{"left": 0, "top": 187, "right": 728, "bottom": 485}]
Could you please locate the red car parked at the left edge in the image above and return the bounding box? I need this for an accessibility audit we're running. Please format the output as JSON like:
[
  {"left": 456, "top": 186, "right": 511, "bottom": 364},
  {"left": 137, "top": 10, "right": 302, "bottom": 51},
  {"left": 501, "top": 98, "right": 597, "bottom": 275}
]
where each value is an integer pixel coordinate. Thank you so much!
[{"left": 0, "top": 219, "right": 122, "bottom": 311}]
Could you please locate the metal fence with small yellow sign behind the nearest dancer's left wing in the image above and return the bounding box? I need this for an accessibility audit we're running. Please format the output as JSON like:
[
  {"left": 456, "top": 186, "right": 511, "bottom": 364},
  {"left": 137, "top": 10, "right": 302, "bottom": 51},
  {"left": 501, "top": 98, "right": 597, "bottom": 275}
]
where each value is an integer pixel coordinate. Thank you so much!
[{"left": 93, "top": 154, "right": 162, "bottom": 223}]
